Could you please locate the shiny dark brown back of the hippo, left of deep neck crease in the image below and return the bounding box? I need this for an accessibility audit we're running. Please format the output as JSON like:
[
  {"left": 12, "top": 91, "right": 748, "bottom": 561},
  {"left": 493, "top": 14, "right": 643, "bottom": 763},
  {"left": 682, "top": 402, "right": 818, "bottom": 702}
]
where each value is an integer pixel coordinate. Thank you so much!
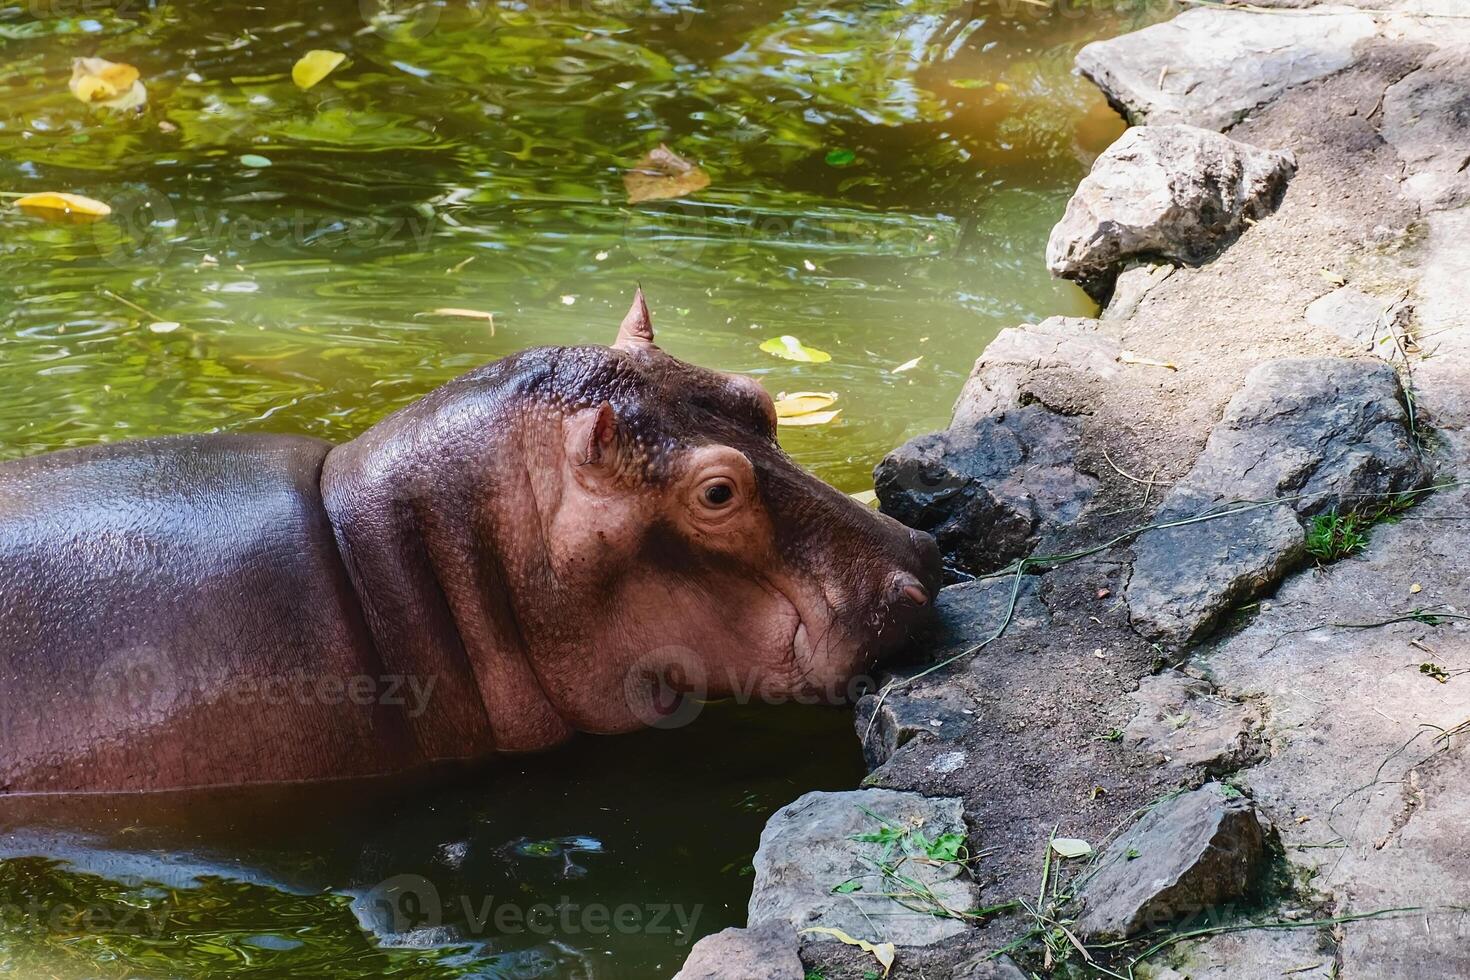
[{"left": 0, "top": 435, "right": 412, "bottom": 792}]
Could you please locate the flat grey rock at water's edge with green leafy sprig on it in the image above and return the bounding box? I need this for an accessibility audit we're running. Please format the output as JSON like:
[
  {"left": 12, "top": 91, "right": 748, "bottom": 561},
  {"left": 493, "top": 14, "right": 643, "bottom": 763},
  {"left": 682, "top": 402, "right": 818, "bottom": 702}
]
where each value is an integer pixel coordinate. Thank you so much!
[{"left": 750, "top": 789, "right": 976, "bottom": 946}]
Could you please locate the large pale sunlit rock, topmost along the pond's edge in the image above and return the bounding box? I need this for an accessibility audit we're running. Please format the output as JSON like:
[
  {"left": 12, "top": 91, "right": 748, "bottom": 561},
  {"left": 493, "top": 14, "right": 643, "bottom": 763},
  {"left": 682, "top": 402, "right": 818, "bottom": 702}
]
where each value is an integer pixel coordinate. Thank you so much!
[{"left": 1078, "top": 7, "right": 1376, "bottom": 131}]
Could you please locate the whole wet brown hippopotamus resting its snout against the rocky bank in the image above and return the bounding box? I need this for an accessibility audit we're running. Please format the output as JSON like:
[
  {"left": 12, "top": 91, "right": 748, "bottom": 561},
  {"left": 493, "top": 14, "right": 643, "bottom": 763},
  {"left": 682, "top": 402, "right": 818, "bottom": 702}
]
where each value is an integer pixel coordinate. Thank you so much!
[{"left": 0, "top": 289, "right": 941, "bottom": 793}]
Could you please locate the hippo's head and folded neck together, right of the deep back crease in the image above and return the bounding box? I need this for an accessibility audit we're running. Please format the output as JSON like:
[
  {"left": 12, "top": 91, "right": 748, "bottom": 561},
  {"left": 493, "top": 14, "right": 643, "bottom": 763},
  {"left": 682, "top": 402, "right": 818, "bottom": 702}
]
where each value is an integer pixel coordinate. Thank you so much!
[{"left": 323, "top": 291, "right": 941, "bottom": 754}]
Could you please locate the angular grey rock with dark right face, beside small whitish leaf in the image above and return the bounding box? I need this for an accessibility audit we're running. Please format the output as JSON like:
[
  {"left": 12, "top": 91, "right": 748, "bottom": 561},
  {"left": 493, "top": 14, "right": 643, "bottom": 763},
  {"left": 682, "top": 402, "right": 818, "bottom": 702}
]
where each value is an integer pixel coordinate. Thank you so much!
[{"left": 1076, "top": 783, "right": 1267, "bottom": 939}]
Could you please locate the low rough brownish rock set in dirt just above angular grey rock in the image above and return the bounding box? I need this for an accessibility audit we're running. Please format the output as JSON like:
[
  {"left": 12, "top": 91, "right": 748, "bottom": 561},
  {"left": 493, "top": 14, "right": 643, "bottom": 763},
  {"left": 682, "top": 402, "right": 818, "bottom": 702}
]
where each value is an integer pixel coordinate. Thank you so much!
[{"left": 1123, "top": 670, "right": 1261, "bottom": 776}]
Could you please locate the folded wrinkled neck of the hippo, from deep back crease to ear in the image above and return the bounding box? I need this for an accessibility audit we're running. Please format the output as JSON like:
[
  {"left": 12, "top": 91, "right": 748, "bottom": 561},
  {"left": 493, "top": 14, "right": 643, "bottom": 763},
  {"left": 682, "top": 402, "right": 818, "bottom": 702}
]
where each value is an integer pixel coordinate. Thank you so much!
[{"left": 322, "top": 359, "right": 572, "bottom": 761}]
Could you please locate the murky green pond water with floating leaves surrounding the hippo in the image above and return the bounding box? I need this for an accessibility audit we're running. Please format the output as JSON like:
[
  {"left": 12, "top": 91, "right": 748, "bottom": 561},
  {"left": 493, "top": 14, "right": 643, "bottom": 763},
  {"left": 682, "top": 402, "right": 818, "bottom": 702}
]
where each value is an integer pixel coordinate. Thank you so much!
[{"left": 0, "top": 0, "right": 1166, "bottom": 977}]
